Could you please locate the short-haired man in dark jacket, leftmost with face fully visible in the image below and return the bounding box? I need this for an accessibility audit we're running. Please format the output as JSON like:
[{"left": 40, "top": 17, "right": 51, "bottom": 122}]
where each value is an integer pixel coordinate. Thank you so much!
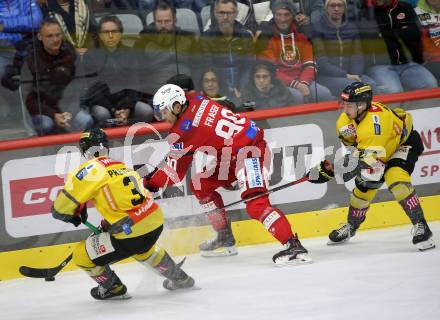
[{"left": 26, "top": 18, "right": 93, "bottom": 135}]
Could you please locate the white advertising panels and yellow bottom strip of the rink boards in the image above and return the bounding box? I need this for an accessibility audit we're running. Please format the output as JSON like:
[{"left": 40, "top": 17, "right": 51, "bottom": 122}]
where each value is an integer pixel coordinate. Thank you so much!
[{"left": 0, "top": 103, "right": 440, "bottom": 280}]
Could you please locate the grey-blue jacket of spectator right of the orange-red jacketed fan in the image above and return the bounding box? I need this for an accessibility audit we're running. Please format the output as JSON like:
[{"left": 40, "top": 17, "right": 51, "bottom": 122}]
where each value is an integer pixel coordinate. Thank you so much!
[{"left": 313, "top": 15, "right": 364, "bottom": 77}]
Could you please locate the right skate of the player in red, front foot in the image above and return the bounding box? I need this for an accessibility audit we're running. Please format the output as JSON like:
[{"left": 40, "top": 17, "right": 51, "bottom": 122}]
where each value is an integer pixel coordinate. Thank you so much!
[{"left": 272, "top": 234, "right": 313, "bottom": 266}]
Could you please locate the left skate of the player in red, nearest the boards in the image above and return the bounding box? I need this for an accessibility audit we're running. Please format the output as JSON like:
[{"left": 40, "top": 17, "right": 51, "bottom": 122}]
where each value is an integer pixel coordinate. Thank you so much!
[{"left": 200, "top": 230, "right": 238, "bottom": 257}]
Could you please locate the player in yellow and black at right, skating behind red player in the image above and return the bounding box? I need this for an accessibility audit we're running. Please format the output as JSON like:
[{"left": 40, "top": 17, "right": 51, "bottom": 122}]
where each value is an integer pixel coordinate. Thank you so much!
[{"left": 310, "top": 82, "right": 435, "bottom": 251}]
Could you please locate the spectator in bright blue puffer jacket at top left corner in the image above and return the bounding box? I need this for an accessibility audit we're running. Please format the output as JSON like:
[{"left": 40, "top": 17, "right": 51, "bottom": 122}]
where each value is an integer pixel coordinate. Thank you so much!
[{"left": 0, "top": 0, "right": 42, "bottom": 123}]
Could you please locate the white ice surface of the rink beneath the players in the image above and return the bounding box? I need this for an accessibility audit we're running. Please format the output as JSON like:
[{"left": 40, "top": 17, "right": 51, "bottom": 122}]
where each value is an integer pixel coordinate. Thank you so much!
[{"left": 0, "top": 222, "right": 440, "bottom": 320}]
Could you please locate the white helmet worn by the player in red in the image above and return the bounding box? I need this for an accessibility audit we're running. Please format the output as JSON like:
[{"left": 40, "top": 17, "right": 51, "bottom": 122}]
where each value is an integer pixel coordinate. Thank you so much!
[{"left": 153, "top": 84, "right": 186, "bottom": 121}]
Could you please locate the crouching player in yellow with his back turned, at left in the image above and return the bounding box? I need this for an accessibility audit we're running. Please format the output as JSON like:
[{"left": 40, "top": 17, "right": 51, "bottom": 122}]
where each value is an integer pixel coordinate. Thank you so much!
[{"left": 52, "top": 128, "right": 194, "bottom": 300}]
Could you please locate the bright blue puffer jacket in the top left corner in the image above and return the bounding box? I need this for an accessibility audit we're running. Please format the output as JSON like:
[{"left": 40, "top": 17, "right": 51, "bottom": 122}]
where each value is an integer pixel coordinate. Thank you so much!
[{"left": 0, "top": 0, "right": 43, "bottom": 47}]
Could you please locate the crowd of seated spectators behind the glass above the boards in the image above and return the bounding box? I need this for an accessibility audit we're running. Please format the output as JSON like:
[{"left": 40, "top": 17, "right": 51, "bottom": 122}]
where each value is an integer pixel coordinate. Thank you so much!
[{"left": 0, "top": 0, "right": 440, "bottom": 135}]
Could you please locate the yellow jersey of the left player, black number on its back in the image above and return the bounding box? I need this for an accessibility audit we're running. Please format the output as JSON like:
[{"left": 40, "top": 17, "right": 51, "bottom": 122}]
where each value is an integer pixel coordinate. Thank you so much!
[{"left": 54, "top": 157, "right": 164, "bottom": 238}]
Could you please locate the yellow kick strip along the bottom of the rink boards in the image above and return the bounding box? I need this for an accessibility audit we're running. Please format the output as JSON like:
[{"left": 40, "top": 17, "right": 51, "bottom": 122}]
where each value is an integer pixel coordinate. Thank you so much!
[{"left": 0, "top": 195, "right": 440, "bottom": 280}]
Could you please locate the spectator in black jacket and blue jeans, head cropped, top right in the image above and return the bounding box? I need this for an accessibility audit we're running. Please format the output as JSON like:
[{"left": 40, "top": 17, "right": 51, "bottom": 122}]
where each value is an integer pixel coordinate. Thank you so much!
[{"left": 367, "top": 0, "right": 437, "bottom": 93}]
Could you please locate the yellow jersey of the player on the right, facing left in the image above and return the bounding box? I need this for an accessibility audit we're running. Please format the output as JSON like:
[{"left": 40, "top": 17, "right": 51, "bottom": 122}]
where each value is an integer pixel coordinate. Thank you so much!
[{"left": 336, "top": 102, "right": 412, "bottom": 163}]
